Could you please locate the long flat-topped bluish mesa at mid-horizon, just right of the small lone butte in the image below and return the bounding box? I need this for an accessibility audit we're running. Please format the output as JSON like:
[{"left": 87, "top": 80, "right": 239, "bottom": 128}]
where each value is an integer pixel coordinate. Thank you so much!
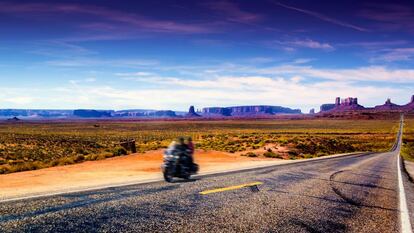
[{"left": 202, "top": 105, "right": 302, "bottom": 117}]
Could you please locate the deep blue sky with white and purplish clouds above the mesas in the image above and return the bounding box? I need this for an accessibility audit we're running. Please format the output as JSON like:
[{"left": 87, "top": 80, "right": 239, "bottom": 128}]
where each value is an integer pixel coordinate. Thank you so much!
[{"left": 0, "top": 0, "right": 414, "bottom": 112}]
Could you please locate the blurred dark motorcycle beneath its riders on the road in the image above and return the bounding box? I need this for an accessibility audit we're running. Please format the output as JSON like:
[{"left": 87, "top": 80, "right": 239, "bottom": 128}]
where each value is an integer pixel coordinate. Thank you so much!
[{"left": 161, "top": 150, "right": 198, "bottom": 182}]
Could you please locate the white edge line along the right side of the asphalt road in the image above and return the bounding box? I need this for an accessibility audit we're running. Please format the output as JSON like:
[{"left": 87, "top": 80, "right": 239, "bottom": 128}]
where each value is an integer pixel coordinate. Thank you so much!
[{"left": 397, "top": 116, "right": 413, "bottom": 233}]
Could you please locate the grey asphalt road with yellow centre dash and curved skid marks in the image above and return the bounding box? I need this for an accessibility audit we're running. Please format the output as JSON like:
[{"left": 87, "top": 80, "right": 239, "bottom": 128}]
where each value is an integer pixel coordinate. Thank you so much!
[{"left": 0, "top": 123, "right": 412, "bottom": 233}]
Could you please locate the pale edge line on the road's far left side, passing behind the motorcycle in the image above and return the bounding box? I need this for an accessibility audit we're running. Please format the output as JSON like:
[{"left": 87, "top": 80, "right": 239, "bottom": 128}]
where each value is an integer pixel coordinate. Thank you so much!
[{"left": 0, "top": 152, "right": 370, "bottom": 203}]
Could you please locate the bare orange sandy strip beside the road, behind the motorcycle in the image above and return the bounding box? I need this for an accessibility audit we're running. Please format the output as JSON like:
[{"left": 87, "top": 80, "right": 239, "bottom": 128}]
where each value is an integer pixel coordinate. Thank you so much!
[{"left": 0, "top": 150, "right": 277, "bottom": 199}]
